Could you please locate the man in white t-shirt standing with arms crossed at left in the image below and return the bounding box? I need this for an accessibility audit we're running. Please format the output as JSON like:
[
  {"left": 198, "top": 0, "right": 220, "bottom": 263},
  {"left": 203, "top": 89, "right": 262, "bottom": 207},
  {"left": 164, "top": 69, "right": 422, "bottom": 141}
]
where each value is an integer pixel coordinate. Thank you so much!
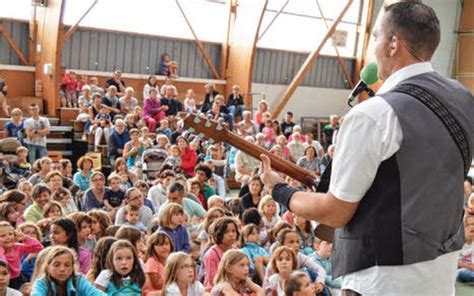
[{"left": 24, "top": 104, "right": 50, "bottom": 164}]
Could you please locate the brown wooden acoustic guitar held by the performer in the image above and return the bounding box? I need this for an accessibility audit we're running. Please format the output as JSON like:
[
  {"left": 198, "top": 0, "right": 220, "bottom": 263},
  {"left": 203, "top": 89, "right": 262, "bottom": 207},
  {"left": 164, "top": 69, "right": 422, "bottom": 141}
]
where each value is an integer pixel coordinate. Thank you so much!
[{"left": 178, "top": 112, "right": 334, "bottom": 242}]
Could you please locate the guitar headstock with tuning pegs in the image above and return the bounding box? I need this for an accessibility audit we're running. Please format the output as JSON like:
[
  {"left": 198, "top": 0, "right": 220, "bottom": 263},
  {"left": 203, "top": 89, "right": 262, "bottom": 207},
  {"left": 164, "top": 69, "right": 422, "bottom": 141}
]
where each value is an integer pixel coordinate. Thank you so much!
[{"left": 178, "top": 112, "right": 227, "bottom": 144}]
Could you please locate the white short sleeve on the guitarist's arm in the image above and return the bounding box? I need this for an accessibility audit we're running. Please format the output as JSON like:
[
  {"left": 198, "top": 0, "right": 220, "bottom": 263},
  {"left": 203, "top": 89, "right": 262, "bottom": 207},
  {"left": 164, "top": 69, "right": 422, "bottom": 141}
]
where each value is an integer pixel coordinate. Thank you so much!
[{"left": 329, "top": 97, "right": 402, "bottom": 202}]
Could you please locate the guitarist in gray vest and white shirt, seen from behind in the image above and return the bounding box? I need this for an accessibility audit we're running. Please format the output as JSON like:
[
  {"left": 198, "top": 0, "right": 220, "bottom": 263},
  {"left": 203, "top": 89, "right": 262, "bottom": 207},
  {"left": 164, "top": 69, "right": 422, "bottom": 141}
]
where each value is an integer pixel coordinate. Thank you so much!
[{"left": 261, "top": 1, "right": 474, "bottom": 295}]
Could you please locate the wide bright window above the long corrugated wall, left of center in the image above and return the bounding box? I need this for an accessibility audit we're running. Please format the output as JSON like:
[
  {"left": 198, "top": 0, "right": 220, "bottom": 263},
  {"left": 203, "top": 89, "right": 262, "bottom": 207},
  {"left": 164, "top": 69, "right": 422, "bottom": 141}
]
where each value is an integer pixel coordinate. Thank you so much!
[{"left": 64, "top": 0, "right": 226, "bottom": 43}]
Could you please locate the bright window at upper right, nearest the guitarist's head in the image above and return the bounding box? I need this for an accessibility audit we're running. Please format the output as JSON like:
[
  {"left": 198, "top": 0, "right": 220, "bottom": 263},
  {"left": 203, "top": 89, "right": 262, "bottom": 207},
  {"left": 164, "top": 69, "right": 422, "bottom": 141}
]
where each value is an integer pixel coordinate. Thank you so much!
[{"left": 257, "top": 0, "right": 360, "bottom": 57}]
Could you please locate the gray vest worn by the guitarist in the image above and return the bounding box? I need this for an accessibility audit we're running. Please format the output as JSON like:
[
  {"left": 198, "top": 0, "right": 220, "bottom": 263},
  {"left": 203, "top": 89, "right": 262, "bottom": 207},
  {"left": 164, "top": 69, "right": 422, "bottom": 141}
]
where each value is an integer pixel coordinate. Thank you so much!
[{"left": 332, "top": 72, "right": 474, "bottom": 278}]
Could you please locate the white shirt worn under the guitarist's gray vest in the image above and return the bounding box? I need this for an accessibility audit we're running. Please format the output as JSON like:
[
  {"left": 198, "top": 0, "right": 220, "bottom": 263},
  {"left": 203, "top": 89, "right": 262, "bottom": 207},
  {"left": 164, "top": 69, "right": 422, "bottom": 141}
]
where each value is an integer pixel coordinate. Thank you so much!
[{"left": 329, "top": 63, "right": 459, "bottom": 295}]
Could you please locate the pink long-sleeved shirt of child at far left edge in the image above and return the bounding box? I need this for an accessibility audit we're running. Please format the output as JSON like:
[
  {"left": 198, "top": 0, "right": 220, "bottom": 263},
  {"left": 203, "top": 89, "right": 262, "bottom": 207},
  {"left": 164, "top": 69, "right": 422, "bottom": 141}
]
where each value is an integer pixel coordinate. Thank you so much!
[{"left": 0, "top": 236, "right": 43, "bottom": 279}]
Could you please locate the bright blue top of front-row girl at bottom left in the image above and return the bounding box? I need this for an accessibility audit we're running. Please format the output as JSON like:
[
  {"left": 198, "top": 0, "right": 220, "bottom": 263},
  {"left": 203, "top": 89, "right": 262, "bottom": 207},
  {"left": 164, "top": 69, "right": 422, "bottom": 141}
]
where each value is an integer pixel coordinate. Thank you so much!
[{"left": 31, "top": 275, "right": 107, "bottom": 296}]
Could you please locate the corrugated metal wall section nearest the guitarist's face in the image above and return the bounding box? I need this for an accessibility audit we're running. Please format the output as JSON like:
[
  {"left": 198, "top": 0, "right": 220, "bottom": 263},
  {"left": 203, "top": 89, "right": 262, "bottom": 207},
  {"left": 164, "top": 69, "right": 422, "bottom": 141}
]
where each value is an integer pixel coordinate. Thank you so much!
[{"left": 253, "top": 49, "right": 354, "bottom": 88}]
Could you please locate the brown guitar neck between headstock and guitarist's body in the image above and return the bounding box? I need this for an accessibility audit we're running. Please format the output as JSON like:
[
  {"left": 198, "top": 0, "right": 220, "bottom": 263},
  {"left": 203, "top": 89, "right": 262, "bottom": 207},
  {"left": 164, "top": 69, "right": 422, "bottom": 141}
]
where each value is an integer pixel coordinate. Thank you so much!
[{"left": 225, "top": 131, "right": 316, "bottom": 188}]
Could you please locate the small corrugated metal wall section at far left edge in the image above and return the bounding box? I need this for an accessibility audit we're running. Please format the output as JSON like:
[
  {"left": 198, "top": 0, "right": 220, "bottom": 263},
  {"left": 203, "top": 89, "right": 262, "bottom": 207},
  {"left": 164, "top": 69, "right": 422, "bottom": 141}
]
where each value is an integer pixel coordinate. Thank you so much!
[{"left": 0, "top": 20, "right": 29, "bottom": 65}]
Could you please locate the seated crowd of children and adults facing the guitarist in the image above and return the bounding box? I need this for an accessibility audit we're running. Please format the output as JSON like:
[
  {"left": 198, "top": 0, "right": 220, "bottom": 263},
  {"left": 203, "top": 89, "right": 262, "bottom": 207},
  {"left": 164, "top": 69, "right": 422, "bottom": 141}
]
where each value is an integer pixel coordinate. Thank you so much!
[{"left": 0, "top": 67, "right": 474, "bottom": 296}]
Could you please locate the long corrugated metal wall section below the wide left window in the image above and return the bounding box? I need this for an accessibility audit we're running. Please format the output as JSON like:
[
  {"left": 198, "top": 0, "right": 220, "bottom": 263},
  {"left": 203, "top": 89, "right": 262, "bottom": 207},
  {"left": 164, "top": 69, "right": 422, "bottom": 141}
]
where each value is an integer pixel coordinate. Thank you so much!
[{"left": 62, "top": 29, "right": 221, "bottom": 78}]
